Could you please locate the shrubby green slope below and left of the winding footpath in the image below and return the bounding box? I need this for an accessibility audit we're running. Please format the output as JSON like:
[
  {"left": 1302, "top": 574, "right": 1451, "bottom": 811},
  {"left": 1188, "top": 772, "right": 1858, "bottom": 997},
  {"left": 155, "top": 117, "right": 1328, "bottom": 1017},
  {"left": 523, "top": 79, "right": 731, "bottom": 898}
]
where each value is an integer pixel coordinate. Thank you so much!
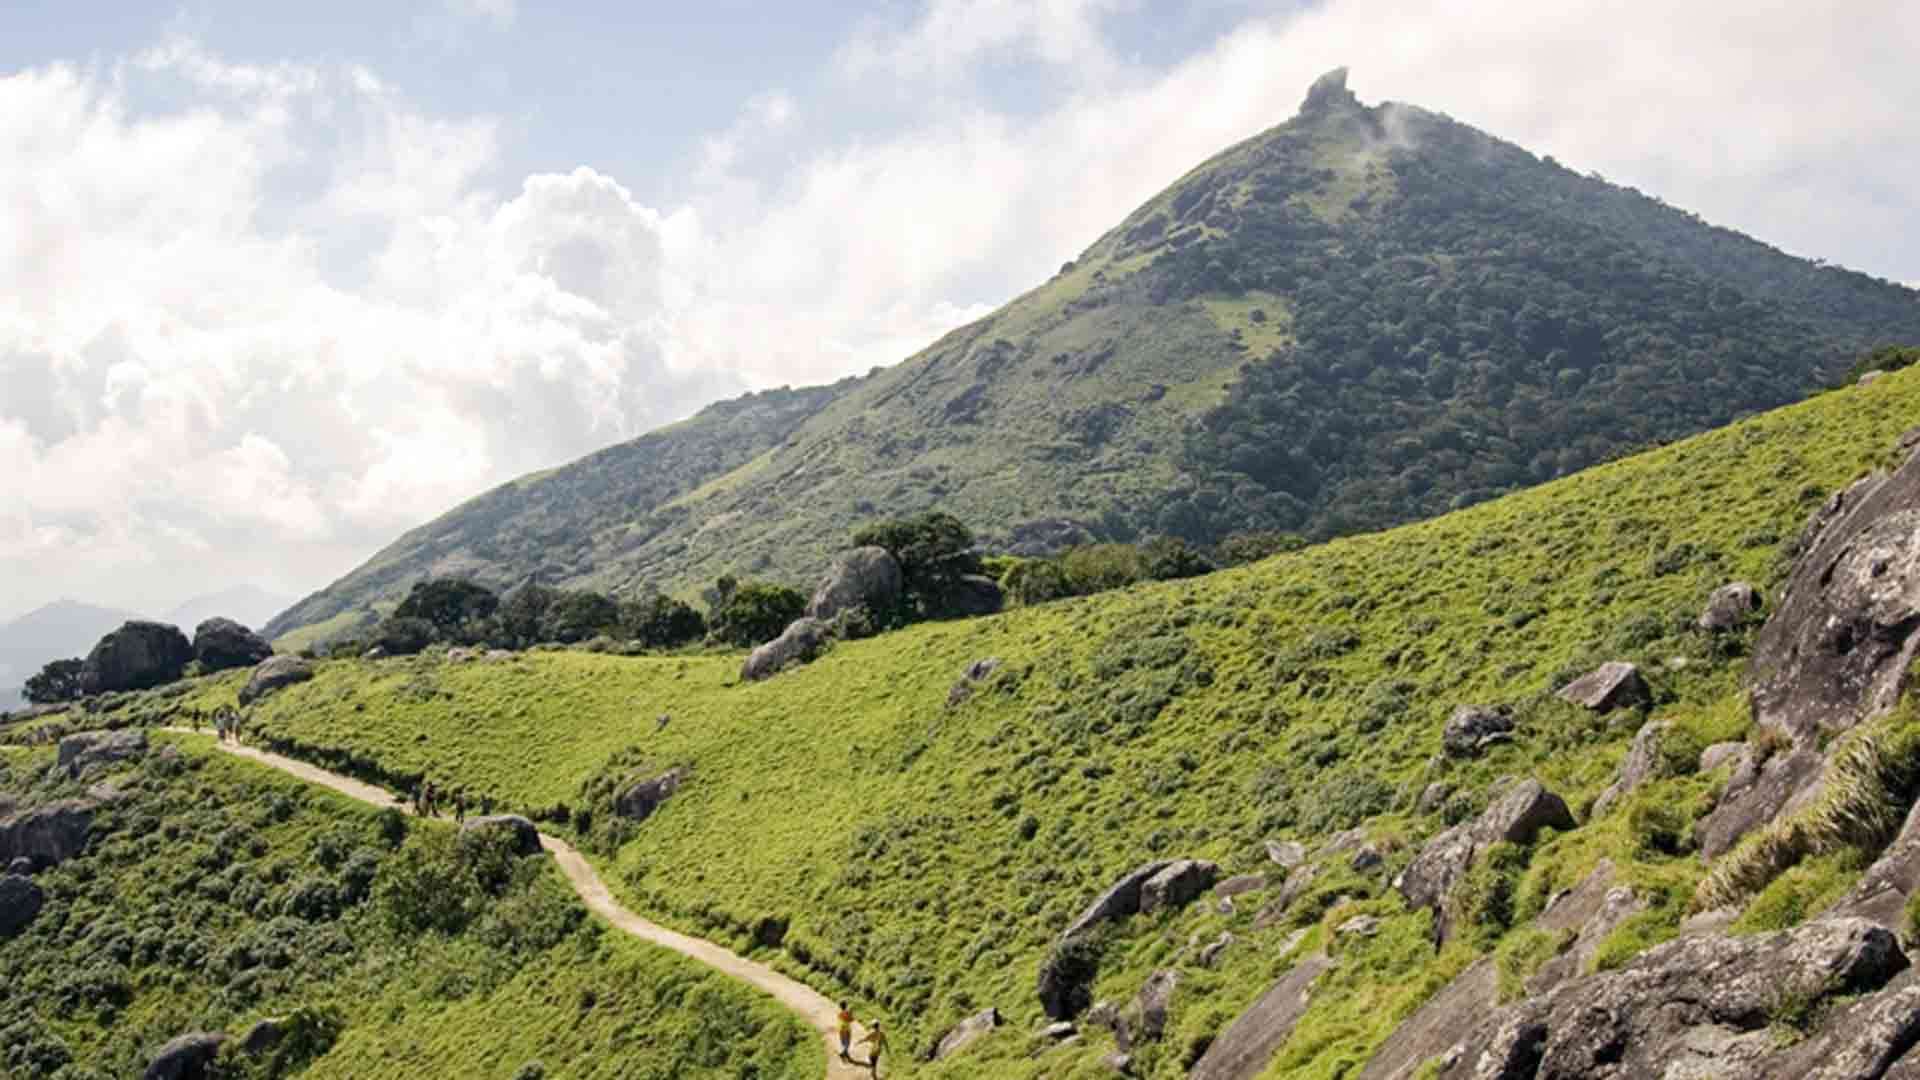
[{"left": 0, "top": 740, "right": 822, "bottom": 1080}]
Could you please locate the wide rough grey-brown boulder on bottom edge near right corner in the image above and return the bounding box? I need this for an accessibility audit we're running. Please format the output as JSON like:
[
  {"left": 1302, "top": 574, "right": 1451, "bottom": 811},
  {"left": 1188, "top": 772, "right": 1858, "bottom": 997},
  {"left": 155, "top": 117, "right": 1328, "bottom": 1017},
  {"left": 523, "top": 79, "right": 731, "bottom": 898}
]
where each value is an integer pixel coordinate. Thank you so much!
[{"left": 1440, "top": 919, "right": 1907, "bottom": 1080}]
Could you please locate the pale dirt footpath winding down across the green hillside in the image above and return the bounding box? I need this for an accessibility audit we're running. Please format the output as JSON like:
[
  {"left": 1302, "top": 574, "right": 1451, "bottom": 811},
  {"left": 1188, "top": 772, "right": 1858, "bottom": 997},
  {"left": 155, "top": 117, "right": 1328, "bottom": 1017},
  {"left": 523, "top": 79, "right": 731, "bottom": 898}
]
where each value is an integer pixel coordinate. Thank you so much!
[{"left": 159, "top": 726, "right": 868, "bottom": 1080}]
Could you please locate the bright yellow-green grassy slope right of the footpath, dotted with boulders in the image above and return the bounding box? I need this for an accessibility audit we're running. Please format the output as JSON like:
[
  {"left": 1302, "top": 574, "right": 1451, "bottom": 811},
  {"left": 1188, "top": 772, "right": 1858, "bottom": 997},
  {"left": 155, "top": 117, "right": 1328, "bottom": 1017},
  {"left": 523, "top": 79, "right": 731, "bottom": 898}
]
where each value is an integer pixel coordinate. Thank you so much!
[{"left": 161, "top": 365, "right": 1920, "bottom": 1076}]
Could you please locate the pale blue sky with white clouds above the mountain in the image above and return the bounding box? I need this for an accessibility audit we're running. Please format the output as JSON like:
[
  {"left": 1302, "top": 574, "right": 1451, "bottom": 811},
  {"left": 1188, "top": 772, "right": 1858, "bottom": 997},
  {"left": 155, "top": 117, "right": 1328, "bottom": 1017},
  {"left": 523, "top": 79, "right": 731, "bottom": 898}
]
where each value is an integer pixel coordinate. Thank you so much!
[{"left": 0, "top": 0, "right": 1920, "bottom": 619}]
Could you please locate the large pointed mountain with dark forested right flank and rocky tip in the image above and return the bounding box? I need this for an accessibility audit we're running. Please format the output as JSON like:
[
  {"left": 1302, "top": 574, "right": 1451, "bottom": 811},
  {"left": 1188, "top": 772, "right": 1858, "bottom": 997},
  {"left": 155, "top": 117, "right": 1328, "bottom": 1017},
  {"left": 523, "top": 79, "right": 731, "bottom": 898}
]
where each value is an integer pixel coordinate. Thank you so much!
[{"left": 269, "top": 71, "right": 1920, "bottom": 636}]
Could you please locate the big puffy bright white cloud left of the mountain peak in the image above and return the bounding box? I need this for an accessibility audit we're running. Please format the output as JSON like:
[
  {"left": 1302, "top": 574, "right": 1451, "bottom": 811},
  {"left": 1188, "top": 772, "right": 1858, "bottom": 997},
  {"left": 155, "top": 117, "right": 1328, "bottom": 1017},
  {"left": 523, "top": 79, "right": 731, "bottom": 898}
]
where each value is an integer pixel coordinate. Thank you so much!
[{"left": 0, "top": 44, "right": 743, "bottom": 609}]
